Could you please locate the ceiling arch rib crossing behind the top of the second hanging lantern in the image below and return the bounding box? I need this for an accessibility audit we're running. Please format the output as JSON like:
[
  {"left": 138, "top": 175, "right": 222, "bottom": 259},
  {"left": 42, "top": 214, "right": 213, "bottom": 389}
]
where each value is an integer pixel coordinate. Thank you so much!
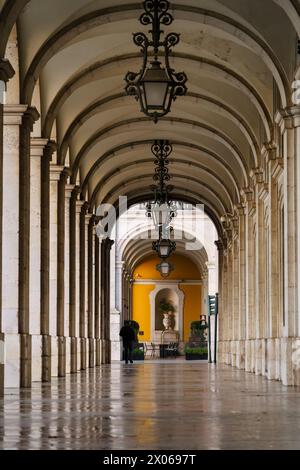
[{"left": 82, "top": 140, "right": 240, "bottom": 202}]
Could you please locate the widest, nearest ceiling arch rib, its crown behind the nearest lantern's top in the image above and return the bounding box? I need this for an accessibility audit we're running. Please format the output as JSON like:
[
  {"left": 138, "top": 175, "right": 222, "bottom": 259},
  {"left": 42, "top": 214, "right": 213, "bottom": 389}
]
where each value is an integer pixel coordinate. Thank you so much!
[{"left": 21, "top": 4, "right": 289, "bottom": 106}]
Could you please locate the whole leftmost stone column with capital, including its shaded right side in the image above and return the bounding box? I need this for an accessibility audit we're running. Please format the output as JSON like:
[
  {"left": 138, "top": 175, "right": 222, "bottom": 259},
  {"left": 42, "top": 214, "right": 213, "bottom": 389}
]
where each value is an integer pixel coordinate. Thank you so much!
[{"left": 2, "top": 105, "right": 38, "bottom": 387}]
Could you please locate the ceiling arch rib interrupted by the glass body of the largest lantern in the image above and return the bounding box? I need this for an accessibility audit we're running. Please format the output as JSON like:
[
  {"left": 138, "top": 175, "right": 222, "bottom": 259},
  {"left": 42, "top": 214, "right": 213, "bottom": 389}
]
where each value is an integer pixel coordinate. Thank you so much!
[{"left": 59, "top": 93, "right": 259, "bottom": 164}]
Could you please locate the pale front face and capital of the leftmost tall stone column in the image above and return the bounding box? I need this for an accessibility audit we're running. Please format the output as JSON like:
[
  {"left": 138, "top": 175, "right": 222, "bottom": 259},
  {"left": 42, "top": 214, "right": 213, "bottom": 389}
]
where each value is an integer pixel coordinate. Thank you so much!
[{"left": 1, "top": 105, "right": 27, "bottom": 387}]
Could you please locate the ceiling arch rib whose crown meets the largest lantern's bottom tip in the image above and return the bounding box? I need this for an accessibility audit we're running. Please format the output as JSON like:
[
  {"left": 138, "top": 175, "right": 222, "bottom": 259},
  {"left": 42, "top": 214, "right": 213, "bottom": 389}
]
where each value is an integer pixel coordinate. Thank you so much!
[{"left": 71, "top": 118, "right": 251, "bottom": 185}]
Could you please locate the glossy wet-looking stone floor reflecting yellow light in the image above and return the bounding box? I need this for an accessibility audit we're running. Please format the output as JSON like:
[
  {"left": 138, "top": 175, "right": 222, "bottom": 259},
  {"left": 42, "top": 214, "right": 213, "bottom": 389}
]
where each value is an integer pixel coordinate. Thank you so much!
[{"left": 0, "top": 359, "right": 300, "bottom": 450}]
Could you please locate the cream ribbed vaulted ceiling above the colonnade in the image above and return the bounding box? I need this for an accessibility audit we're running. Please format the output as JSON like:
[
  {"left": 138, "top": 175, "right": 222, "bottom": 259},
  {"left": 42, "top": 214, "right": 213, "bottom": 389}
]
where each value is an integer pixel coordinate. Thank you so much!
[{"left": 0, "top": 0, "right": 300, "bottom": 232}]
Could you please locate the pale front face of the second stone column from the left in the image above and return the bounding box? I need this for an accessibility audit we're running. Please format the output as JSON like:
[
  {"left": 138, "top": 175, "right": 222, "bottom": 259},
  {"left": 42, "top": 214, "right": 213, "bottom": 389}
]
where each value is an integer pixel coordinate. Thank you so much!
[{"left": 30, "top": 138, "right": 48, "bottom": 382}]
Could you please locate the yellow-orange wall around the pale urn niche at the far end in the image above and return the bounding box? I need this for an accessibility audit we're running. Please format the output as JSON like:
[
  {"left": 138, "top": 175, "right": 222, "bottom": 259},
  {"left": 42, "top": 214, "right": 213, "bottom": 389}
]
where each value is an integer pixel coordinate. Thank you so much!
[{"left": 132, "top": 255, "right": 202, "bottom": 341}]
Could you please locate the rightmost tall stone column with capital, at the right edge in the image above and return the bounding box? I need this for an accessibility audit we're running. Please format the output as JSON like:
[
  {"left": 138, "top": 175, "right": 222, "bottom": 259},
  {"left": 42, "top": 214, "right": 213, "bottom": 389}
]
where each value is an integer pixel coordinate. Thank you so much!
[{"left": 277, "top": 106, "right": 300, "bottom": 385}]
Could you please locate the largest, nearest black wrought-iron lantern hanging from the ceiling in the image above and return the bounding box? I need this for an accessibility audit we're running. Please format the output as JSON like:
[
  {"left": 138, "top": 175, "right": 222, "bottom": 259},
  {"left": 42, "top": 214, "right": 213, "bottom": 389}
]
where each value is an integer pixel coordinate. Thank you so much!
[{"left": 125, "top": 0, "right": 187, "bottom": 123}]
